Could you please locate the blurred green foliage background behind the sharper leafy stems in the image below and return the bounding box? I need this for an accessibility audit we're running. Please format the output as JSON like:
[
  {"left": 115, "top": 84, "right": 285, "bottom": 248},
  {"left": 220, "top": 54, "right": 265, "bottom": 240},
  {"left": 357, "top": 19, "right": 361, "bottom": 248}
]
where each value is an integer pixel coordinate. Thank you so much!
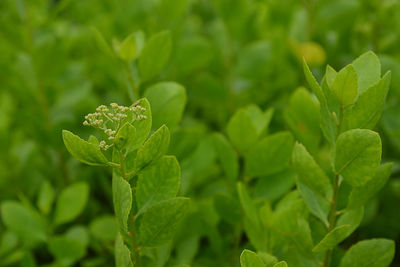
[{"left": 0, "top": 0, "right": 400, "bottom": 266}]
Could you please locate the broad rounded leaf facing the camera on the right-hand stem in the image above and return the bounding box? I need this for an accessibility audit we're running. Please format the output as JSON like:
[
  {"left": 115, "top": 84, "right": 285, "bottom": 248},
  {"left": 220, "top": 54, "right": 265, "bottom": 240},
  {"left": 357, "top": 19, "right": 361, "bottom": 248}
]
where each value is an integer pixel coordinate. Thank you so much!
[{"left": 335, "top": 129, "right": 382, "bottom": 187}]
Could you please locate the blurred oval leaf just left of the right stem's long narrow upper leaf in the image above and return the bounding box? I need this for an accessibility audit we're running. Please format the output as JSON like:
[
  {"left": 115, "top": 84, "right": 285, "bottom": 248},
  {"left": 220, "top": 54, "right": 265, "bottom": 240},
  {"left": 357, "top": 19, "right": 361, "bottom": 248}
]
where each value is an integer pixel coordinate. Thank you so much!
[{"left": 284, "top": 87, "right": 321, "bottom": 155}]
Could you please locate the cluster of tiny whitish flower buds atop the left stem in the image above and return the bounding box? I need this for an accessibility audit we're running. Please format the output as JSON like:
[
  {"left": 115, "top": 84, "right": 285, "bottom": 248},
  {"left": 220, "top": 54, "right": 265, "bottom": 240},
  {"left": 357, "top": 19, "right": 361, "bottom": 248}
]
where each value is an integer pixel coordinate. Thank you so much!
[{"left": 83, "top": 103, "right": 147, "bottom": 150}]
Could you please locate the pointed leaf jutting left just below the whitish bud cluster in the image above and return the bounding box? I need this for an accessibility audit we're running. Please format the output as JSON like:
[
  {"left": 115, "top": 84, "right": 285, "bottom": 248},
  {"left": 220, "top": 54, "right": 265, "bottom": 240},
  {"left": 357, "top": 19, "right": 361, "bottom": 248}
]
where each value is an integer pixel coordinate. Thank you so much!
[{"left": 62, "top": 130, "right": 108, "bottom": 166}]
